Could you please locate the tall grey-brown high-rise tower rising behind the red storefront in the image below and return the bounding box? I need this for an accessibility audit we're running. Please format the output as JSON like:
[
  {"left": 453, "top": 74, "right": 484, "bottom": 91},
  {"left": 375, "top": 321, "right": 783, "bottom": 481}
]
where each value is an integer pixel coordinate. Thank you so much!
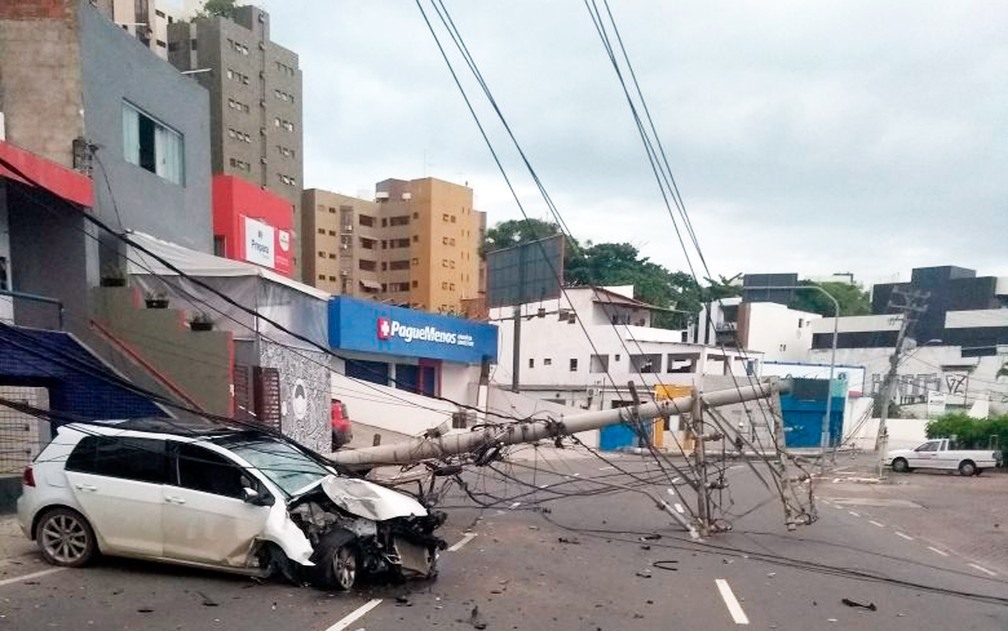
[{"left": 168, "top": 6, "right": 303, "bottom": 278}]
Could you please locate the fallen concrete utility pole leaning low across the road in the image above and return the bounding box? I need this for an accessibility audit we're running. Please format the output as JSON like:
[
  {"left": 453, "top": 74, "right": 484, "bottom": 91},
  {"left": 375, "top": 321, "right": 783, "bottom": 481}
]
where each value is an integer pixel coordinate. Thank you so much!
[{"left": 332, "top": 381, "right": 790, "bottom": 469}]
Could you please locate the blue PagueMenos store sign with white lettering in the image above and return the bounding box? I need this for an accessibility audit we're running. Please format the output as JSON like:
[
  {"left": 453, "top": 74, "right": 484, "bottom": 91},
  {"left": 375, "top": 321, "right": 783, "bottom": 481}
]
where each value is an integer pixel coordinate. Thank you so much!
[{"left": 329, "top": 296, "right": 497, "bottom": 364}]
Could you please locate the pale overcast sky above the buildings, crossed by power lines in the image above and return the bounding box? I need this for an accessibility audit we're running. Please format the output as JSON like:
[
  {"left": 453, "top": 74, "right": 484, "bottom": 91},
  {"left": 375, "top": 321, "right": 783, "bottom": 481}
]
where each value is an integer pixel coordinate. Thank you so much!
[{"left": 259, "top": 0, "right": 1008, "bottom": 283}]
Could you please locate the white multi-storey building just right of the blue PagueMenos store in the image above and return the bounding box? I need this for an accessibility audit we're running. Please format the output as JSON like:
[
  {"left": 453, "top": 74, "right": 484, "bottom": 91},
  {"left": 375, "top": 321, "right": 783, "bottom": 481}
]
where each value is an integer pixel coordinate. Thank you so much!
[{"left": 490, "top": 286, "right": 762, "bottom": 409}]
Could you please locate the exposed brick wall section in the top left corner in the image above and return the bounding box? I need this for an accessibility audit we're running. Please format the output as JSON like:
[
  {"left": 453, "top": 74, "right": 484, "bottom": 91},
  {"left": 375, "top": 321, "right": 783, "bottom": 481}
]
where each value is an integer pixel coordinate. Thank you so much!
[{"left": 0, "top": 0, "right": 84, "bottom": 166}]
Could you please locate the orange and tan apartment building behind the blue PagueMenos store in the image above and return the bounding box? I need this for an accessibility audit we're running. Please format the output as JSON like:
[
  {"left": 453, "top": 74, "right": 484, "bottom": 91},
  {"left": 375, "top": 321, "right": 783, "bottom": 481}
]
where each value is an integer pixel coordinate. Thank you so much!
[{"left": 302, "top": 177, "right": 486, "bottom": 313}]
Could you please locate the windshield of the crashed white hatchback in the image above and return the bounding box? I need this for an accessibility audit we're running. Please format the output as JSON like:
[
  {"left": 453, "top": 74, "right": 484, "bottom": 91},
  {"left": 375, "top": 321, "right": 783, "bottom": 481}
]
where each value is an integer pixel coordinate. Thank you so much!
[{"left": 218, "top": 437, "right": 332, "bottom": 497}]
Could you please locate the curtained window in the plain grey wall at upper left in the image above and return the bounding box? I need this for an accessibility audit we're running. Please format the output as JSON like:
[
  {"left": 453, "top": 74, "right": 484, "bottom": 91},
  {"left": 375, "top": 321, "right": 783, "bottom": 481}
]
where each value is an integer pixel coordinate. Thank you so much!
[{"left": 123, "top": 102, "right": 184, "bottom": 184}]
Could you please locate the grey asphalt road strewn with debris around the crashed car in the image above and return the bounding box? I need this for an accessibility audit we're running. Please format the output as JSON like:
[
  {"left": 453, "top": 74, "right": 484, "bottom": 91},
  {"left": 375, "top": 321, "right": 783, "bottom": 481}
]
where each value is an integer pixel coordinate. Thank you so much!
[{"left": 0, "top": 453, "right": 1008, "bottom": 631}]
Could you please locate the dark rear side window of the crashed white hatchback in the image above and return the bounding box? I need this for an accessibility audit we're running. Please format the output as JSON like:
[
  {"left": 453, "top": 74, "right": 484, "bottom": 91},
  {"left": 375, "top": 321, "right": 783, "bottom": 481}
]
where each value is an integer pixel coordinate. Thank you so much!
[{"left": 67, "top": 435, "right": 168, "bottom": 484}]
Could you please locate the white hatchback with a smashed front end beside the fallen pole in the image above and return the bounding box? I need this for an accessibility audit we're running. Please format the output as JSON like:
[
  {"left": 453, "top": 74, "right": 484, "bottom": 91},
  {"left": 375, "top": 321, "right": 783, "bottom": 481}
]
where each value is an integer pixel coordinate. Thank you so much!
[{"left": 17, "top": 419, "right": 445, "bottom": 590}]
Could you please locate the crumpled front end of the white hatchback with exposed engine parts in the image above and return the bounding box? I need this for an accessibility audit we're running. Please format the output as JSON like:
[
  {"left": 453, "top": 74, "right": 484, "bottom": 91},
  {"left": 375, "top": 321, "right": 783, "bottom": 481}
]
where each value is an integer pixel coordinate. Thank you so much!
[{"left": 287, "top": 476, "right": 446, "bottom": 590}]
